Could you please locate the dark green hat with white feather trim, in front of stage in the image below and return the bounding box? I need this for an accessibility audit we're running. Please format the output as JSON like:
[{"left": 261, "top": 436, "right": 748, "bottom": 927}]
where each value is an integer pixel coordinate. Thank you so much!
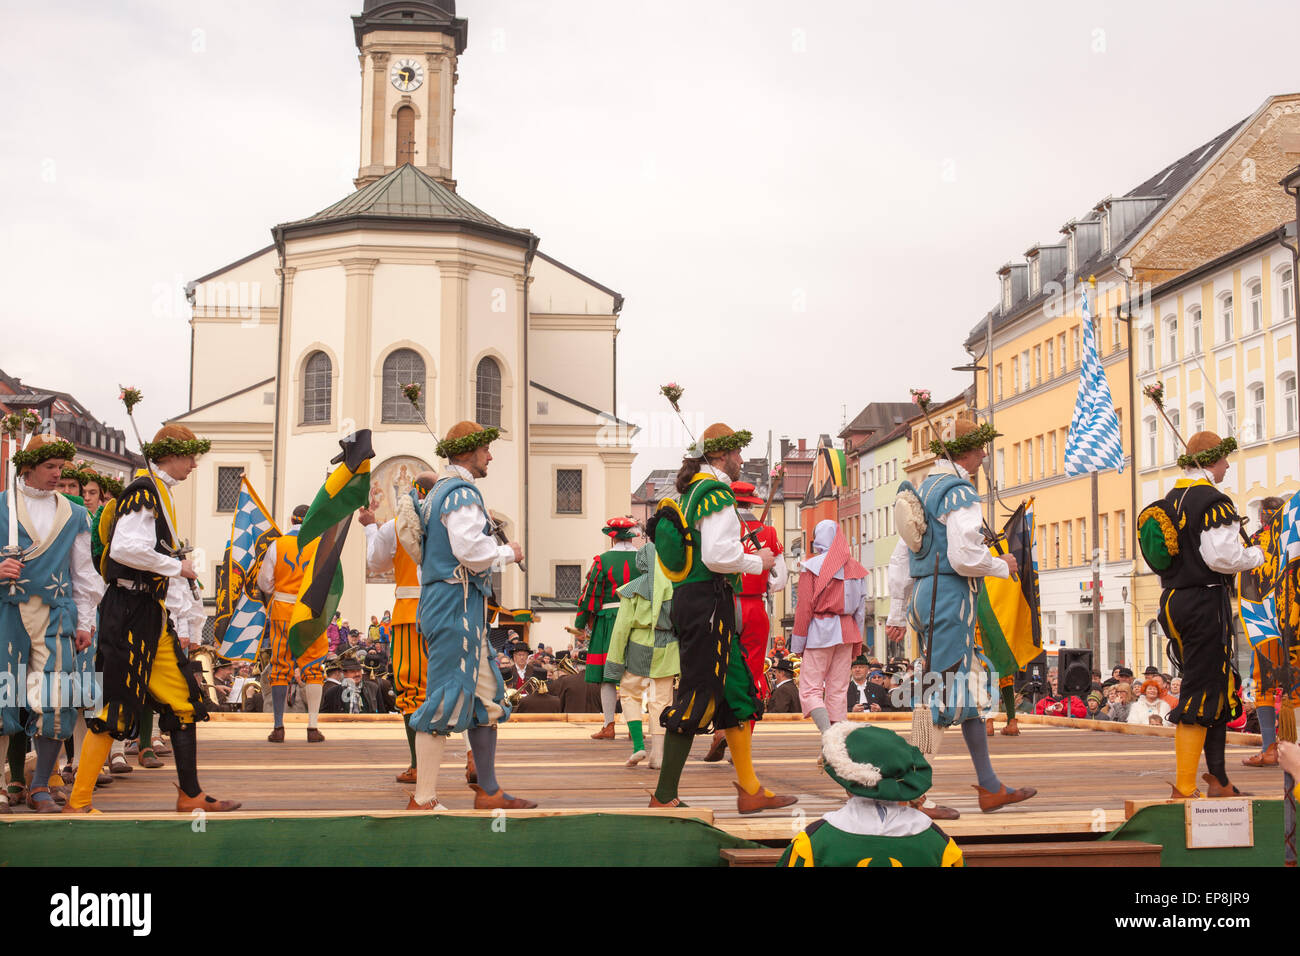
[{"left": 822, "top": 721, "right": 932, "bottom": 803}]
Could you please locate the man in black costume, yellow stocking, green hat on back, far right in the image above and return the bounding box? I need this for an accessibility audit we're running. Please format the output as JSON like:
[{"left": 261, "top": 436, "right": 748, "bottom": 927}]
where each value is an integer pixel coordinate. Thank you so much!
[{"left": 1138, "top": 432, "right": 1264, "bottom": 800}]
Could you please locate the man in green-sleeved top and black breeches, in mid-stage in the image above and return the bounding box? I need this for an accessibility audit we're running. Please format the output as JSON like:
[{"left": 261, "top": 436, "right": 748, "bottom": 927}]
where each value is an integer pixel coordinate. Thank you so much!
[{"left": 650, "top": 423, "right": 797, "bottom": 813}]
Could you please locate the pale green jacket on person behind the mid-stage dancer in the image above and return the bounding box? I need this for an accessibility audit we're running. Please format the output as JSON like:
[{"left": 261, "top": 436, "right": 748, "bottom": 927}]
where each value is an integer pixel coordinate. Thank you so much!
[{"left": 605, "top": 544, "right": 681, "bottom": 680}]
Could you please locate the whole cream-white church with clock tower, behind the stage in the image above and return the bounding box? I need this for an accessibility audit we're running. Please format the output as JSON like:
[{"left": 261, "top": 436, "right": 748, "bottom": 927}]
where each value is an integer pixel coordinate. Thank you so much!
[{"left": 172, "top": 0, "right": 634, "bottom": 646}]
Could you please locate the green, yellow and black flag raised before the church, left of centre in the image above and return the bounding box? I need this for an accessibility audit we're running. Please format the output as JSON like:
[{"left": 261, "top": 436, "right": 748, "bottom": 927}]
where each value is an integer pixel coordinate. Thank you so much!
[{"left": 289, "top": 428, "right": 374, "bottom": 658}]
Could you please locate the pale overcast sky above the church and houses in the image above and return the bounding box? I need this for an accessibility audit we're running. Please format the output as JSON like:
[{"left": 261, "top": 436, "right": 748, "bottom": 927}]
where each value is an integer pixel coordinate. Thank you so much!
[{"left": 0, "top": 0, "right": 1300, "bottom": 480}]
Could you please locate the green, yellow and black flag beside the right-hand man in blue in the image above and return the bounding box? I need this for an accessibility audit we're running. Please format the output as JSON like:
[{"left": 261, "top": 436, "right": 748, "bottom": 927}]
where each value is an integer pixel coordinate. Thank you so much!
[{"left": 975, "top": 498, "right": 1043, "bottom": 678}]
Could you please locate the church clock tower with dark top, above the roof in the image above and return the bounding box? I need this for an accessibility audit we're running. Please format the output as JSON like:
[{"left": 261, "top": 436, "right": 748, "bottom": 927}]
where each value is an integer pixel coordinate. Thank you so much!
[{"left": 352, "top": 0, "right": 469, "bottom": 189}]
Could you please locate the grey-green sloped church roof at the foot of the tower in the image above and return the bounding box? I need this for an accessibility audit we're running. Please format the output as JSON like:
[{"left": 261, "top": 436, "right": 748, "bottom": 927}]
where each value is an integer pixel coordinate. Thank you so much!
[{"left": 276, "top": 164, "right": 537, "bottom": 247}]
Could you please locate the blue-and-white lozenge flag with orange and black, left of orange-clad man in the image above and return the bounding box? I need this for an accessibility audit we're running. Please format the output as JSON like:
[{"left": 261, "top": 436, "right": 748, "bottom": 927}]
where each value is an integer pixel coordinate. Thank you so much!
[{"left": 213, "top": 476, "right": 280, "bottom": 661}]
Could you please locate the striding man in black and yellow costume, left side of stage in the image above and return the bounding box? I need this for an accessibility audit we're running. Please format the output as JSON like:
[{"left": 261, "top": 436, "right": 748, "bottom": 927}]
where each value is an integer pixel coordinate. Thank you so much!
[{"left": 64, "top": 425, "right": 239, "bottom": 813}]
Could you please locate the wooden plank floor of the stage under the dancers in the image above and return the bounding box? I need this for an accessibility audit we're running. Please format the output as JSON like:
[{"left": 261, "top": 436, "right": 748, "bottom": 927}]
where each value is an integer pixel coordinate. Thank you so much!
[{"left": 35, "top": 717, "right": 1282, "bottom": 840}]
